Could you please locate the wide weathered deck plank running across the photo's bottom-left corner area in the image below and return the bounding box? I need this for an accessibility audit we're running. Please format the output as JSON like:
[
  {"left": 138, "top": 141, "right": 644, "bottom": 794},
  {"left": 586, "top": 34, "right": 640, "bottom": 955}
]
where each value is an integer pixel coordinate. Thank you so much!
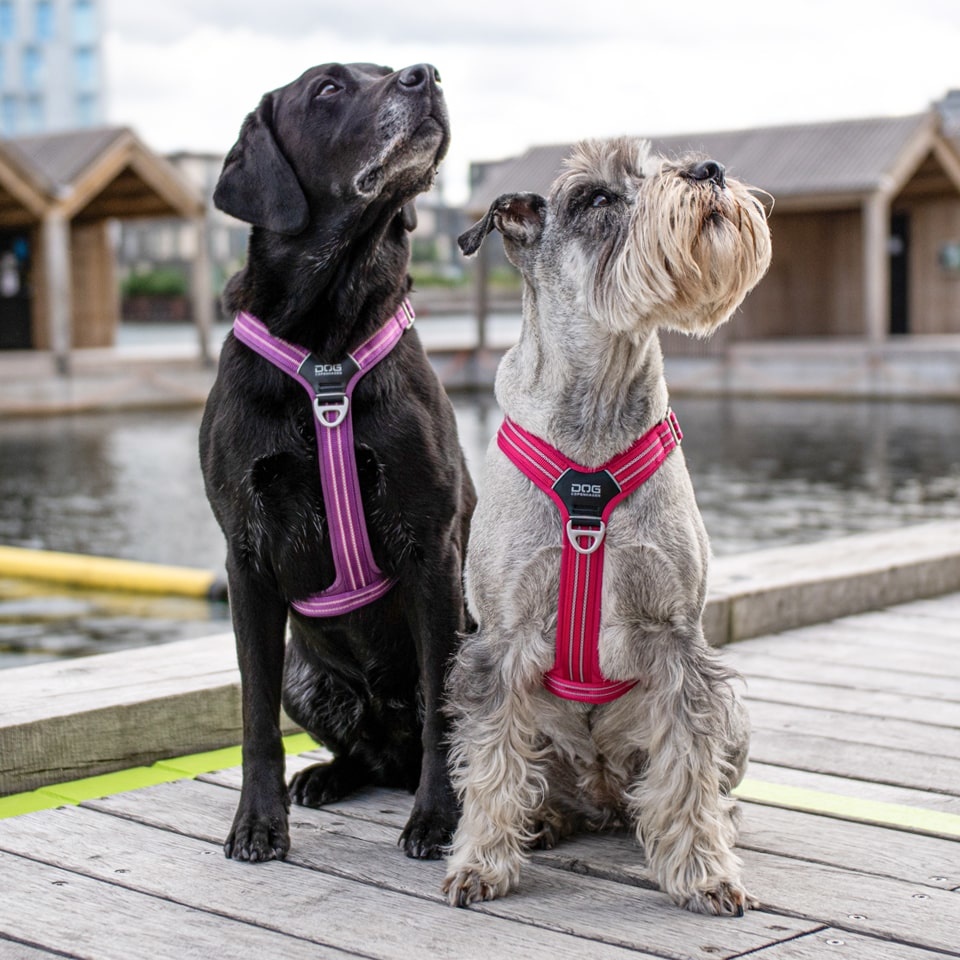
[{"left": 0, "top": 852, "right": 357, "bottom": 960}]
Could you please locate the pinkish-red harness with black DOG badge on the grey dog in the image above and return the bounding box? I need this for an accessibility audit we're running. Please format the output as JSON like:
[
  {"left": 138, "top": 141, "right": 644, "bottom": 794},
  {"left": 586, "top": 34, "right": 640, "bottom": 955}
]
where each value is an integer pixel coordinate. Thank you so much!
[{"left": 497, "top": 410, "right": 683, "bottom": 703}]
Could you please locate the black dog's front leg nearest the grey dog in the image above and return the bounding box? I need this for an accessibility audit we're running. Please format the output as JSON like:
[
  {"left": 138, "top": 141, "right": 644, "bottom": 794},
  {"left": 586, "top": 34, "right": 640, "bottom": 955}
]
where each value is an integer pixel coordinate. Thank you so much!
[{"left": 400, "top": 545, "right": 464, "bottom": 860}]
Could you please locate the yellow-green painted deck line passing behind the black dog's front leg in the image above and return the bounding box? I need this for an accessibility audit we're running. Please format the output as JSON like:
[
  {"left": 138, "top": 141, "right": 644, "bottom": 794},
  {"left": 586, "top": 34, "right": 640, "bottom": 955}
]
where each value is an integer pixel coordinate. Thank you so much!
[{"left": 0, "top": 733, "right": 318, "bottom": 820}]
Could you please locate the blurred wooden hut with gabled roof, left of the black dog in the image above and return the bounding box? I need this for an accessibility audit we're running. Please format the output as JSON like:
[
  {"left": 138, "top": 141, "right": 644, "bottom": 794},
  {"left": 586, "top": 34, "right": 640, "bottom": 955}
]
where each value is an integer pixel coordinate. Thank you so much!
[{"left": 0, "top": 128, "right": 210, "bottom": 366}]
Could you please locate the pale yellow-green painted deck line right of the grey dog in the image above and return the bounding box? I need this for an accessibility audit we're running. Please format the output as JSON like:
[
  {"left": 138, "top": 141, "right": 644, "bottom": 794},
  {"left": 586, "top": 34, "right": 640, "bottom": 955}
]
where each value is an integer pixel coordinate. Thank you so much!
[{"left": 733, "top": 777, "right": 960, "bottom": 838}]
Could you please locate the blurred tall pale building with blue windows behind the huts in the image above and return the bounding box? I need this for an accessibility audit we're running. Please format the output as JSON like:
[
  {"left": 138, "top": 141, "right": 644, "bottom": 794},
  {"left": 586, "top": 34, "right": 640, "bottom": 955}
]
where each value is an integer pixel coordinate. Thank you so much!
[{"left": 0, "top": 0, "right": 105, "bottom": 137}]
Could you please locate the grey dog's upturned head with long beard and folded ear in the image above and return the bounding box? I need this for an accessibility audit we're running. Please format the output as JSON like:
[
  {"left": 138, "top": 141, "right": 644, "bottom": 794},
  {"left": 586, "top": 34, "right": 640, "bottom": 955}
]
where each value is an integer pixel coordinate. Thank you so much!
[{"left": 460, "top": 138, "right": 770, "bottom": 337}]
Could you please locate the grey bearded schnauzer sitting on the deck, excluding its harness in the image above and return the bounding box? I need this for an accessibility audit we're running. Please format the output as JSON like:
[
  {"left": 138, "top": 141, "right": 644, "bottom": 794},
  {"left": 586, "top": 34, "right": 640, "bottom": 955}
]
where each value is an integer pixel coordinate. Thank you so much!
[{"left": 444, "top": 138, "right": 770, "bottom": 915}]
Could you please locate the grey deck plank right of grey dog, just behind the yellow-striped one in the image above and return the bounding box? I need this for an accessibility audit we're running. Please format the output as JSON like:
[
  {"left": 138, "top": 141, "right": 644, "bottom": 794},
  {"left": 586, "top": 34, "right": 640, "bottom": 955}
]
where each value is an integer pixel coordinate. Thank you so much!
[{"left": 750, "top": 727, "right": 960, "bottom": 795}]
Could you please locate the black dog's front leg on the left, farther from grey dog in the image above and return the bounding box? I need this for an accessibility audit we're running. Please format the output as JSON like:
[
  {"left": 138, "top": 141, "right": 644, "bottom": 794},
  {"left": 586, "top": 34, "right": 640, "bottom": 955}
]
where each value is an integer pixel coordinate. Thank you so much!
[{"left": 223, "top": 564, "right": 290, "bottom": 861}]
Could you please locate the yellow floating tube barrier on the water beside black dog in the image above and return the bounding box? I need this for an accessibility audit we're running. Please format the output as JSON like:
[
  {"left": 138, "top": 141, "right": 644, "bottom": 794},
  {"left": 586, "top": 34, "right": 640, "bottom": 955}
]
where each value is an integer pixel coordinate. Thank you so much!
[{"left": 0, "top": 546, "right": 226, "bottom": 600}]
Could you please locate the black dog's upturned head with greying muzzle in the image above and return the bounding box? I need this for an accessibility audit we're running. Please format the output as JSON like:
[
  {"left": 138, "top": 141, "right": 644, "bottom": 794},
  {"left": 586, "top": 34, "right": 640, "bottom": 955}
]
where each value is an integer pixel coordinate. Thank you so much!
[{"left": 213, "top": 63, "right": 450, "bottom": 236}]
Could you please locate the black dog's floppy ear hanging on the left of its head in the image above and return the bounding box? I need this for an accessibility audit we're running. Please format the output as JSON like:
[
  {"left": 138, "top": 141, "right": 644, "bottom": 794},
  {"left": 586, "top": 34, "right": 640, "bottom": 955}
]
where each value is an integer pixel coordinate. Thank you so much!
[{"left": 213, "top": 94, "right": 310, "bottom": 237}]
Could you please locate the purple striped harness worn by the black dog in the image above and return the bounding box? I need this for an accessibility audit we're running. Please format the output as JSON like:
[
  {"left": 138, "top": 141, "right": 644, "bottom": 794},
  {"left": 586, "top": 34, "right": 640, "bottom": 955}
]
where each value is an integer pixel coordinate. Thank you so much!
[{"left": 233, "top": 300, "right": 414, "bottom": 617}]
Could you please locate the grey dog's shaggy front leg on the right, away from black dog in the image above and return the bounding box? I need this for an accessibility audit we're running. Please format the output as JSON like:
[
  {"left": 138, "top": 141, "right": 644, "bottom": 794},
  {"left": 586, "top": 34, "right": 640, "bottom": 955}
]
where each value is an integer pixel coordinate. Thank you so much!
[{"left": 629, "top": 653, "right": 756, "bottom": 915}]
